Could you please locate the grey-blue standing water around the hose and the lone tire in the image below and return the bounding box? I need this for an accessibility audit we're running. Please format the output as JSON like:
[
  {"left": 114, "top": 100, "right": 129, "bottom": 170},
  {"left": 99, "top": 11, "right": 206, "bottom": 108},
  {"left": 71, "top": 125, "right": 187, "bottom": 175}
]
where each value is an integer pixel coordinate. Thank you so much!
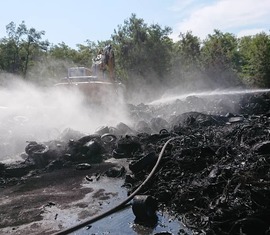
[{"left": 55, "top": 177, "right": 191, "bottom": 235}]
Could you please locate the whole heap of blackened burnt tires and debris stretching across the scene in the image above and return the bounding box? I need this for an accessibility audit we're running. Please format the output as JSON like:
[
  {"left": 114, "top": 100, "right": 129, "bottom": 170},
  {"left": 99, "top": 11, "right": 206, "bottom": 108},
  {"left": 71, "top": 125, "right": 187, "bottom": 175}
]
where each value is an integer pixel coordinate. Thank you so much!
[{"left": 0, "top": 93, "right": 270, "bottom": 234}]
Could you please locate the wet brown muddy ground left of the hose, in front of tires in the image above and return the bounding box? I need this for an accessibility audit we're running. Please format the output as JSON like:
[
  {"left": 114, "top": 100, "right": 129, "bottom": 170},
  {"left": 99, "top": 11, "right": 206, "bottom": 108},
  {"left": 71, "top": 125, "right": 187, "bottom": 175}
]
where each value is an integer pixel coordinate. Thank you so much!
[{"left": 0, "top": 163, "right": 127, "bottom": 234}]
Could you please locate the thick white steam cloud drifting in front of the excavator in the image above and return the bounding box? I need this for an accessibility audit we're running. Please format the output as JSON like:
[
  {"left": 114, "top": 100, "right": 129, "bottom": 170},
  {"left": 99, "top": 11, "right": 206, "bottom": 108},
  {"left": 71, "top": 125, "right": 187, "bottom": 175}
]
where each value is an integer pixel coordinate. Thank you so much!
[{"left": 0, "top": 75, "right": 128, "bottom": 161}]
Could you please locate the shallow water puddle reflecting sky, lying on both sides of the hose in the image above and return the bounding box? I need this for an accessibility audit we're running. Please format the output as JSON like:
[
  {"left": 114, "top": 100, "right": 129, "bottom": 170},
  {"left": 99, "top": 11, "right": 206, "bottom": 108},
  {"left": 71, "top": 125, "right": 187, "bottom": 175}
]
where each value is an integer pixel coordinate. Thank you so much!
[{"left": 59, "top": 177, "right": 192, "bottom": 235}]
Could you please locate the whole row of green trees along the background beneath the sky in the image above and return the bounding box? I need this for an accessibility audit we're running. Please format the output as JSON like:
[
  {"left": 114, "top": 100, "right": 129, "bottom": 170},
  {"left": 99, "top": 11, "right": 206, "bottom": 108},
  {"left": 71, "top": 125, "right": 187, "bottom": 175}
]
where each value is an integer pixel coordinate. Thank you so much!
[{"left": 0, "top": 14, "right": 270, "bottom": 91}]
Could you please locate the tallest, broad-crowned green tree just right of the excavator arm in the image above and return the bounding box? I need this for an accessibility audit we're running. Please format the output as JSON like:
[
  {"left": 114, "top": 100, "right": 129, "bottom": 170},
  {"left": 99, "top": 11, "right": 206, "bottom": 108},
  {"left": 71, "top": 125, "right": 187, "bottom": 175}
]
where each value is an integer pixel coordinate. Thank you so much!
[{"left": 112, "top": 14, "right": 172, "bottom": 83}]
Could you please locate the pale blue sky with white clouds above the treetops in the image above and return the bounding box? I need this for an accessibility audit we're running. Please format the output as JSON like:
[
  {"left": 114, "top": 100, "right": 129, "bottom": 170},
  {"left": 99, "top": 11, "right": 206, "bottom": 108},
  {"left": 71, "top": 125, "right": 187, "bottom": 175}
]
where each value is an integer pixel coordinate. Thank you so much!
[{"left": 0, "top": 0, "right": 270, "bottom": 48}]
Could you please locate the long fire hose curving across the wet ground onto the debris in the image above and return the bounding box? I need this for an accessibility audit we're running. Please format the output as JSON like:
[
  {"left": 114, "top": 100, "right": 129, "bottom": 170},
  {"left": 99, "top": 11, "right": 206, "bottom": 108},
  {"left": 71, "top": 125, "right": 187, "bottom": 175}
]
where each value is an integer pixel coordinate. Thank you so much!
[{"left": 55, "top": 137, "right": 179, "bottom": 235}]
